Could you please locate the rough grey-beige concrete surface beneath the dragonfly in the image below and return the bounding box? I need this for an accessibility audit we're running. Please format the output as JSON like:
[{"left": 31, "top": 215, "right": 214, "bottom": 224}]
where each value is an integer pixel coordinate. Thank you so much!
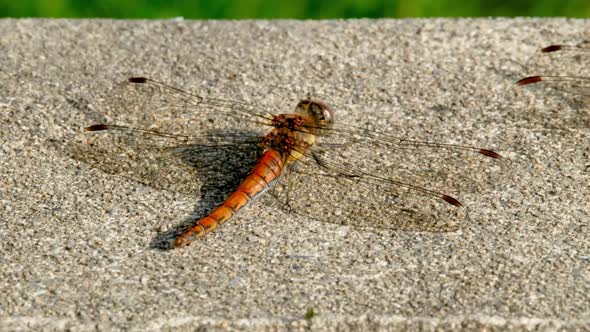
[{"left": 0, "top": 19, "right": 590, "bottom": 331}]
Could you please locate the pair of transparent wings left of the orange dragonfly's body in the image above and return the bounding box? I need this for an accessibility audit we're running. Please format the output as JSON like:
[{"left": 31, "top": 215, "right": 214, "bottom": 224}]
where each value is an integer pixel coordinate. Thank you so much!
[{"left": 66, "top": 78, "right": 270, "bottom": 194}]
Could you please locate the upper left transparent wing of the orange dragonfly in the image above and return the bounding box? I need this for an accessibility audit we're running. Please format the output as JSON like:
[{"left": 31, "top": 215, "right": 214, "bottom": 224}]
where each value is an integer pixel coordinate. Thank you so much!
[{"left": 101, "top": 79, "right": 272, "bottom": 135}]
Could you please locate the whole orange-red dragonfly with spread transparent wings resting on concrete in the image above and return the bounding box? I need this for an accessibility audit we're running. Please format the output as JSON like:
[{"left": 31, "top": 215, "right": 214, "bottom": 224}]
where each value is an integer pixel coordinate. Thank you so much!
[{"left": 75, "top": 77, "right": 502, "bottom": 248}]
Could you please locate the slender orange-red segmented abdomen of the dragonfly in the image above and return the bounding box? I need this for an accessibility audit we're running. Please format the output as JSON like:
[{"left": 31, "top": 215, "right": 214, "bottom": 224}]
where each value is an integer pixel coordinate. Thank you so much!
[{"left": 174, "top": 149, "right": 285, "bottom": 247}]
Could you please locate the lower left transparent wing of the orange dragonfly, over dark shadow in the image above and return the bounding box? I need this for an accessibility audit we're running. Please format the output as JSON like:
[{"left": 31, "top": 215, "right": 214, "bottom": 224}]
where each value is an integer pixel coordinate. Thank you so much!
[{"left": 64, "top": 122, "right": 261, "bottom": 194}]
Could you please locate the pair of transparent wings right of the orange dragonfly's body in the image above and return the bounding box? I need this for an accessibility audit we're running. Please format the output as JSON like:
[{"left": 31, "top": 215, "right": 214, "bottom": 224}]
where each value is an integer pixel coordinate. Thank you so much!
[{"left": 272, "top": 130, "right": 499, "bottom": 232}]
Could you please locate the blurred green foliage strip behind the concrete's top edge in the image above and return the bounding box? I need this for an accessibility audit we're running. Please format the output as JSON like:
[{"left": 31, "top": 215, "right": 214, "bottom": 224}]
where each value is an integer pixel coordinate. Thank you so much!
[{"left": 0, "top": 0, "right": 590, "bottom": 19}]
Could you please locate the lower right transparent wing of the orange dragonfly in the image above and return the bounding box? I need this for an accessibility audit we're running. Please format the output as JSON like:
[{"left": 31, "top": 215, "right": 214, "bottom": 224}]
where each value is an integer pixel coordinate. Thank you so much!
[{"left": 271, "top": 157, "right": 466, "bottom": 232}]
